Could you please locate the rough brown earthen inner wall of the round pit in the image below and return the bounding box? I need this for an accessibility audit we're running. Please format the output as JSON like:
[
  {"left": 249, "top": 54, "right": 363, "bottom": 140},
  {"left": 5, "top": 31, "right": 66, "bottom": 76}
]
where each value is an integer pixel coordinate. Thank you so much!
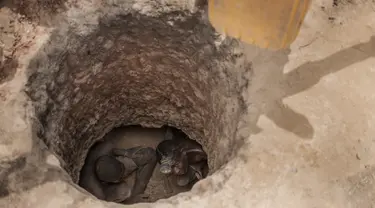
[{"left": 26, "top": 12, "right": 251, "bottom": 204}]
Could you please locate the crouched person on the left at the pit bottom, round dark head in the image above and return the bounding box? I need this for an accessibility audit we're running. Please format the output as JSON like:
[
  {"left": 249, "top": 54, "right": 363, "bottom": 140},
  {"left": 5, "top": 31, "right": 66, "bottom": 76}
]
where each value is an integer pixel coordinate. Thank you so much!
[{"left": 79, "top": 141, "right": 157, "bottom": 203}]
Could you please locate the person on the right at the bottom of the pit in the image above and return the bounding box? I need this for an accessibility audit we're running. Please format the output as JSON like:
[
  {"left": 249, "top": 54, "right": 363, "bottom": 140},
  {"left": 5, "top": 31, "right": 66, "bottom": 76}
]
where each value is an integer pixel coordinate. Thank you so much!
[{"left": 156, "top": 127, "right": 208, "bottom": 187}]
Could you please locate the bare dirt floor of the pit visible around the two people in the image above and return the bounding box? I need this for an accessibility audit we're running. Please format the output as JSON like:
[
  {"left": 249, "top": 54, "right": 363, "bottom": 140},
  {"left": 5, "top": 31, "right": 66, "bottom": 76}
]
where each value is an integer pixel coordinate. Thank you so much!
[{"left": 104, "top": 126, "right": 191, "bottom": 204}]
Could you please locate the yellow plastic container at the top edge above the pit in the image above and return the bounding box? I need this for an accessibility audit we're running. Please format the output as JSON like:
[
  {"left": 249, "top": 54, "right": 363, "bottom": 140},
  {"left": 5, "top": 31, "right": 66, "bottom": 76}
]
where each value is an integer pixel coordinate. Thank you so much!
[{"left": 208, "top": 0, "right": 311, "bottom": 49}]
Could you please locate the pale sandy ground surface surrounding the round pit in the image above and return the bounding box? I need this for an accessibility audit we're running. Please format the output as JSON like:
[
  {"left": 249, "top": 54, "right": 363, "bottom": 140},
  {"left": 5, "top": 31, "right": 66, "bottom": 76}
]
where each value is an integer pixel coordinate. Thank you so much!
[{"left": 0, "top": 1, "right": 375, "bottom": 207}]
